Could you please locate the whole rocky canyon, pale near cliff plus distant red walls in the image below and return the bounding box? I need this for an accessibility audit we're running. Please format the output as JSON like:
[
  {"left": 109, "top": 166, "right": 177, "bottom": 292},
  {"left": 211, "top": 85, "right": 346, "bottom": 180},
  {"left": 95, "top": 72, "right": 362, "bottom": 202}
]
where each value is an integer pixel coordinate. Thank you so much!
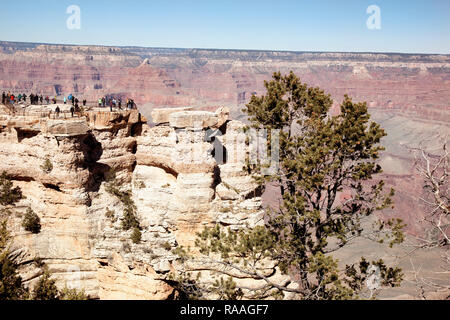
[{"left": 0, "top": 42, "right": 450, "bottom": 299}]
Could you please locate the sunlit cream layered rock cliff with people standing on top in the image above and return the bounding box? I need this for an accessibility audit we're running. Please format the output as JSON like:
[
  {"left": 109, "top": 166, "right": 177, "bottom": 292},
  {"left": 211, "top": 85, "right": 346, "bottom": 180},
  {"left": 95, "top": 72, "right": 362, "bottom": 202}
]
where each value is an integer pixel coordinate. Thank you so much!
[{"left": 0, "top": 105, "right": 268, "bottom": 299}]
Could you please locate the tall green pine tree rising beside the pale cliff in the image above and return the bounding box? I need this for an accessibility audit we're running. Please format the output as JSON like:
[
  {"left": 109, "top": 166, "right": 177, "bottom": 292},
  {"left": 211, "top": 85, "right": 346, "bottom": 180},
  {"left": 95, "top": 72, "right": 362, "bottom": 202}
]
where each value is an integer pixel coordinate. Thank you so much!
[{"left": 181, "top": 72, "right": 403, "bottom": 299}]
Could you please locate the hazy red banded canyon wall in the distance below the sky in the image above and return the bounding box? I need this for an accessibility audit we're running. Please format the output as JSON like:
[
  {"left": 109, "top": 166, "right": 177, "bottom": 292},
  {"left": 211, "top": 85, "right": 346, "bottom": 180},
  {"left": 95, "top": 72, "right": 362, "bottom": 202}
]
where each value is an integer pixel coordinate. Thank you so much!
[{"left": 0, "top": 42, "right": 450, "bottom": 245}]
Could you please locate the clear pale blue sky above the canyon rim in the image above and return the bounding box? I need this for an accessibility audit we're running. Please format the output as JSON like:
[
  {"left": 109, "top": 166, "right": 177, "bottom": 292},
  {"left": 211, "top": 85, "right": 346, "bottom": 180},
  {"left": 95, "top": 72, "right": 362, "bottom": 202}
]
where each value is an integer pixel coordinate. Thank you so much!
[{"left": 0, "top": 0, "right": 450, "bottom": 54}]
